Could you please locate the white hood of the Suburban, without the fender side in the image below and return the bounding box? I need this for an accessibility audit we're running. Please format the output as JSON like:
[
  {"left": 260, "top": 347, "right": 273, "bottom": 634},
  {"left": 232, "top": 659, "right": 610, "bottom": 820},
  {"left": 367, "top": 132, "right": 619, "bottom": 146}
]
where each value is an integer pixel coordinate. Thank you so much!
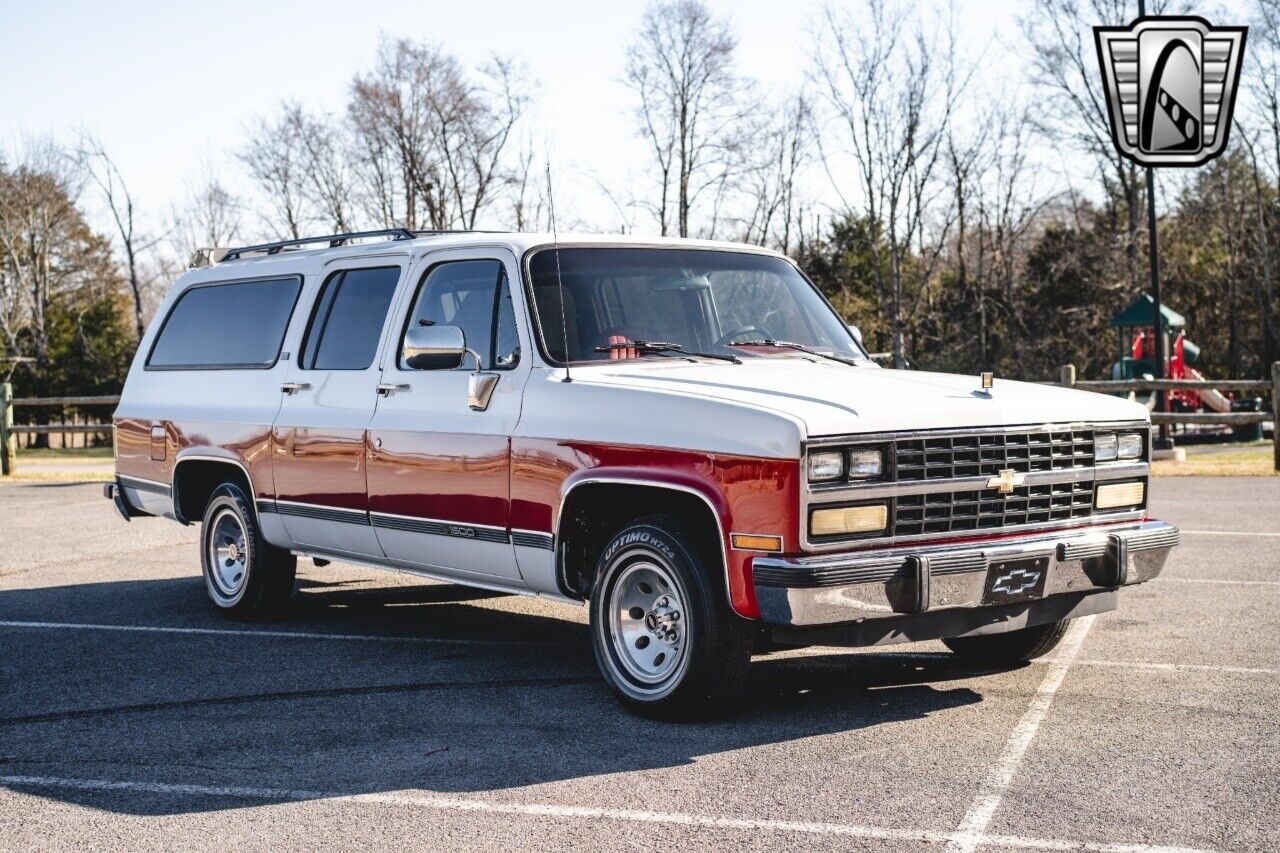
[{"left": 575, "top": 356, "right": 1148, "bottom": 437}]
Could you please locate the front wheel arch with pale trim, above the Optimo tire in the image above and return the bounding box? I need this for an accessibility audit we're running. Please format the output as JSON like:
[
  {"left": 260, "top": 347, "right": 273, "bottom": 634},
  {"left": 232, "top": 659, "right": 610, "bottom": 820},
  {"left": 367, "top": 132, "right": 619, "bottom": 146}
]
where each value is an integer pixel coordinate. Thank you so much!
[{"left": 554, "top": 473, "right": 732, "bottom": 607}]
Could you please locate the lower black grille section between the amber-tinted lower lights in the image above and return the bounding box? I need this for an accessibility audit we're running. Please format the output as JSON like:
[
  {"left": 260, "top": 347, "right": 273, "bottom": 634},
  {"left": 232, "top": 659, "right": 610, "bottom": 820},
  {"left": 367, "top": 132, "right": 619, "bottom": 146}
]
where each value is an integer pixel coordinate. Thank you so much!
[{"left": 891, "top": 481, "right": 1093, "bottom": 537}]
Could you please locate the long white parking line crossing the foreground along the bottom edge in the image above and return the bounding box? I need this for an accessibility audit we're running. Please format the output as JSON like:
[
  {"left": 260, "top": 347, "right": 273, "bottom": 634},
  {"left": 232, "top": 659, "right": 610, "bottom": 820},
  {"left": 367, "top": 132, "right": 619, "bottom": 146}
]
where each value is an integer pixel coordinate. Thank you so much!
[{"left": 0, "top": 776, "right": 1206, "bottom": 853}]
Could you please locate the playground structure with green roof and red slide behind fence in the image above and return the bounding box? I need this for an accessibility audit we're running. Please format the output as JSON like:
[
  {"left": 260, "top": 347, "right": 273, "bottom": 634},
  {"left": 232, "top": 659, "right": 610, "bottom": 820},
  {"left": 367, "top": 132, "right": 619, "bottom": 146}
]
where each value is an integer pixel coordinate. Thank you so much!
[{"left": 1111, "top": 293, "right": 1235, "bottom": 414}]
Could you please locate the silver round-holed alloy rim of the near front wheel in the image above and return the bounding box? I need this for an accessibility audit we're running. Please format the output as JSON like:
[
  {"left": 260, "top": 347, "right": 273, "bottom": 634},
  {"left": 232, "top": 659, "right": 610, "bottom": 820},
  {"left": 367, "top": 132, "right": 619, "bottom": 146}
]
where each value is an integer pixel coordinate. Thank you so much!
[{"left": 608, "top": 558, "right": 689, "bottom": 686}]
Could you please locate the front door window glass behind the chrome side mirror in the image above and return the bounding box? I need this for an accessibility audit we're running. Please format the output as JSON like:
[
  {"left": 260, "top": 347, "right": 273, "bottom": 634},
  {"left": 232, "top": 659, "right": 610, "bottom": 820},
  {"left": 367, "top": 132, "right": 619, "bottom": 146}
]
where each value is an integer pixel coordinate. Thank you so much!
[{"left": 401, "top": 260, "right": 520, "bottom": 370}]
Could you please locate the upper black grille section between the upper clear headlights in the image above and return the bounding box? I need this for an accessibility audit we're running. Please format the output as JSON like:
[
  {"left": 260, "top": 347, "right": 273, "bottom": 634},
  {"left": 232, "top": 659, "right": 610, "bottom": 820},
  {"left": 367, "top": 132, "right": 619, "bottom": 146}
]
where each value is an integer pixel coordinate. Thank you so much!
[{"left": 892, "top": 429, "right": 1093, "bottom": 483}]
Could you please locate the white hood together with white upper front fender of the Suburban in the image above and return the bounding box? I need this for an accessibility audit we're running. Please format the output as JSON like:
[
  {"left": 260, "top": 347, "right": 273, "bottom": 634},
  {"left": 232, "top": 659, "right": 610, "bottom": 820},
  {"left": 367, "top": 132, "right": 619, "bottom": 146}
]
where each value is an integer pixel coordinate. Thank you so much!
[{"left": 521, "top": 353, "right": 1148, "bottom": 457}]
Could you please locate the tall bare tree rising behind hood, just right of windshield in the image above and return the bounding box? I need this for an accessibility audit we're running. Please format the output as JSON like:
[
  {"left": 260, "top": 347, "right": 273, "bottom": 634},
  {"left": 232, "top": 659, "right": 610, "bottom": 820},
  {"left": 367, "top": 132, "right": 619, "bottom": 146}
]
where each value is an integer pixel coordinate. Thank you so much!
[{"left": 814, "top": 0, "right": 964, "bottom": 366}]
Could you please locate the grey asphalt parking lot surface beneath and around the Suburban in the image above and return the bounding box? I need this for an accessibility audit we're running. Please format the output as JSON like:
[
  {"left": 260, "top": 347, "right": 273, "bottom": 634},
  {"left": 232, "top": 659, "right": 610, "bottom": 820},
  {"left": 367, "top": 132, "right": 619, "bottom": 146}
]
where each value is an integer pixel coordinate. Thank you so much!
[{"left": 0, "top": 478, "right": 1280, "bottom": 850}]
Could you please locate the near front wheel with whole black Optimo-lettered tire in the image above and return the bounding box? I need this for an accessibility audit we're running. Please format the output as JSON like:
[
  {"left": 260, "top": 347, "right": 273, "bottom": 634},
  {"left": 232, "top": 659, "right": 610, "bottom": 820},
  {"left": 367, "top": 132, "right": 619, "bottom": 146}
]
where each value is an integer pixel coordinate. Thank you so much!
[{"left": 590, "top": 516, "right": 755, "bottom": 720}]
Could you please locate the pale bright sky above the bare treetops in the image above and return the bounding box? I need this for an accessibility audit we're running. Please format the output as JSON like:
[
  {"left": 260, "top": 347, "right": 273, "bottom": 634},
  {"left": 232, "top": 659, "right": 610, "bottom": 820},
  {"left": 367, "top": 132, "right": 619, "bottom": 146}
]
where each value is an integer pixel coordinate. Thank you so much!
[{"left": 0, "top": 0, "right": 1025, "bottom": 235}]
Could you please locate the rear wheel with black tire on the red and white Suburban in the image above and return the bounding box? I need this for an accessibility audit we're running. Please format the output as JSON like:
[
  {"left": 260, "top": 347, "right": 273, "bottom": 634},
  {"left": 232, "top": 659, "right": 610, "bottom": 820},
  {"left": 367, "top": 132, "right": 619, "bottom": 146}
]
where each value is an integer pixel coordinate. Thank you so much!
[{"left": 200, "top": 483, "right": 298, "bottom": 619}]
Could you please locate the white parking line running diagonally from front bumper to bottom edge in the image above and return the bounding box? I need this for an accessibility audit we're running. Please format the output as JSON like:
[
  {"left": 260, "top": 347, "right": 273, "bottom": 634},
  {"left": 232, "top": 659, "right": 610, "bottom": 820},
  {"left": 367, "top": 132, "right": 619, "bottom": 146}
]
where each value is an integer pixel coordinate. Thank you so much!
[{"left": 946, "top": 616, "right": 1094, "bottom": 853}]
